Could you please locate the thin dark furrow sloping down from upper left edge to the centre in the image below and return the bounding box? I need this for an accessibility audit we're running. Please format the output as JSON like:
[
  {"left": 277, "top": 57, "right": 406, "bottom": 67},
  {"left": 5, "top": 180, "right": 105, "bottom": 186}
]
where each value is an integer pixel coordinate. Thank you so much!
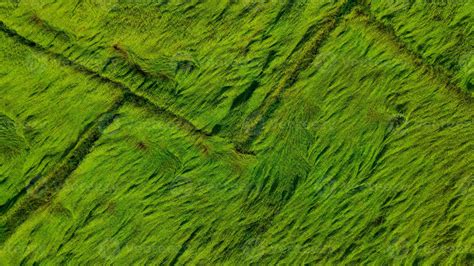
[{"left": 0, "top": 21, "right": 210, "bottom": 139}]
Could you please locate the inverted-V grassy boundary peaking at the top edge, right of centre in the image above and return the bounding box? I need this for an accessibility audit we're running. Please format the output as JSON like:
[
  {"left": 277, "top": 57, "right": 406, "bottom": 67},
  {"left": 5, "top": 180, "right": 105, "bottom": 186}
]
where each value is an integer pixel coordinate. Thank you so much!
[{"left": 241, "top": 0, "right": 472, "bottom": 150}]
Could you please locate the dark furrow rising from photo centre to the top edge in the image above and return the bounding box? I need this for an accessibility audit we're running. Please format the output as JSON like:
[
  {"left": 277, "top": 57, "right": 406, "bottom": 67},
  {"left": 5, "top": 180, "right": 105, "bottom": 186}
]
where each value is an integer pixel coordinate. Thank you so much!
[{"left": 241, "top": 0, "right": 357, "bottom": 150}]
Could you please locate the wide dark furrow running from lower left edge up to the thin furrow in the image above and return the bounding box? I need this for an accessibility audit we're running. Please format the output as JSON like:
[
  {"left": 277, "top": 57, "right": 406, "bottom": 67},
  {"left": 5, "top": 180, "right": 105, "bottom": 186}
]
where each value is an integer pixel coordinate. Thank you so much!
[{"left": 0, "top": 97, "right": 126, "bottom": 243}]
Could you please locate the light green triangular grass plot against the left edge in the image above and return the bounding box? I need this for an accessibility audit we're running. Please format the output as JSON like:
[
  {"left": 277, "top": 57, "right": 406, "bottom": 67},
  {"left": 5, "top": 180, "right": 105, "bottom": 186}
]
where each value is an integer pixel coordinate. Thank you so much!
[{"left": 0, "top": 32, "right": 118, "bottom": 208}]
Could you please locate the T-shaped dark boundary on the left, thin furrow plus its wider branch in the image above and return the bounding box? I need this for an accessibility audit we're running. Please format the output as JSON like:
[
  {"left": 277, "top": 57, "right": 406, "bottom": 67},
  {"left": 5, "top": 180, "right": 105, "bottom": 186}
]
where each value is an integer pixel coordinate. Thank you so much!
[{"left": 0, "top": 21, "right": 252, "bottom": 244}]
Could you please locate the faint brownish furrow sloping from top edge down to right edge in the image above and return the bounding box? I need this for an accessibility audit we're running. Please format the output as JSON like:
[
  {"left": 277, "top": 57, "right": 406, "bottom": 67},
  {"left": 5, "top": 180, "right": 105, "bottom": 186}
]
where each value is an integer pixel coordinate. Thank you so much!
[{"left": 355, "top": 5, "right": 472, "bottom": 102}]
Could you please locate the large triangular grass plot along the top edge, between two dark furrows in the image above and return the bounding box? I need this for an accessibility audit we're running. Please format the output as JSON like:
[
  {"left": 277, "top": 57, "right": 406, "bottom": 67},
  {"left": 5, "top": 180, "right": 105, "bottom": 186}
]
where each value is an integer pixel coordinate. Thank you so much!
[{"left": 0, "top": 0, "right": 345, "bottom": 132}]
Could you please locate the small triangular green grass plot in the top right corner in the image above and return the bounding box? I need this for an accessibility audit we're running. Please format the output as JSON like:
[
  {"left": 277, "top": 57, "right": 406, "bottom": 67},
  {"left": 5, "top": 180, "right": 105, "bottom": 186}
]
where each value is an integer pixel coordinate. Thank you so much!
[{"left": 367, "top": 0, "right": 474, "bottom": 94}]
